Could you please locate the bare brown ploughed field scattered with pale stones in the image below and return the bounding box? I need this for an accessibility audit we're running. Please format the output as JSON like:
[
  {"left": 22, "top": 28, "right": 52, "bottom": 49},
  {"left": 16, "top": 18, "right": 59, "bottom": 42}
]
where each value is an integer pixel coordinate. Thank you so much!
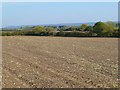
[{"left": 2, "top": 36, "right": 118, "bottom": 88}]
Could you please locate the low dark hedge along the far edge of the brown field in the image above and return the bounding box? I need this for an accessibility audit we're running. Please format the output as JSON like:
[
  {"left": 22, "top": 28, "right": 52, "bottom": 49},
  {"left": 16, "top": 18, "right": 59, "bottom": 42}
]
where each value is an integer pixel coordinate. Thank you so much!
[{"left": 2, "top": 30, "right": 119, "bottom": 37}]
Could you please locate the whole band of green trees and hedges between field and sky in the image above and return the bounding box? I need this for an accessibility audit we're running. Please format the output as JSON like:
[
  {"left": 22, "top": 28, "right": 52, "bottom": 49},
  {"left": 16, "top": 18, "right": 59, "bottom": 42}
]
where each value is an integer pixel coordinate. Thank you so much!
[{"left": 2, "top": 21, "right": 120, "bottom": 37}]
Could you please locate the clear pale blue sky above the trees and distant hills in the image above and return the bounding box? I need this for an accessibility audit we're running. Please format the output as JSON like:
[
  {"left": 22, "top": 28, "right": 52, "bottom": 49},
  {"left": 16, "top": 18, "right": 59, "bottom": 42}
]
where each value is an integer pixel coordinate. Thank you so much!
[{"left": 2, "top": 2, "right": 118, "bottom": 26}]
